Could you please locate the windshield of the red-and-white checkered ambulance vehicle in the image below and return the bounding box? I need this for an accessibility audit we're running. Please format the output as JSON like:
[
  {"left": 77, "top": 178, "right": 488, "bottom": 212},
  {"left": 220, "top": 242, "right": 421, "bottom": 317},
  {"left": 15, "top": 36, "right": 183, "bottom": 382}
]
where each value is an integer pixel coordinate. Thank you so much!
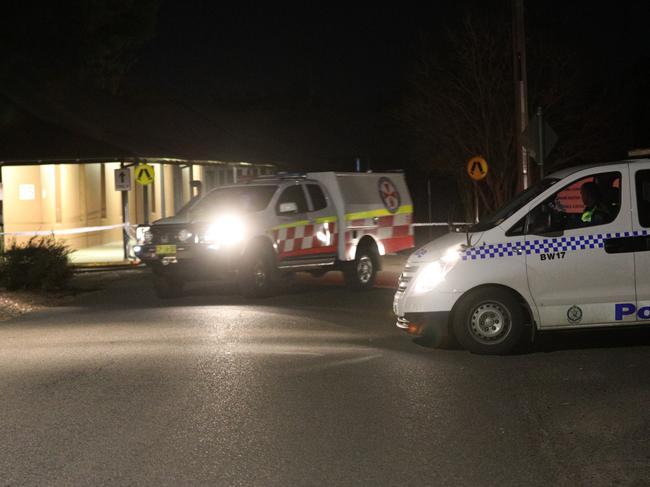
[{"left": 178, "top": 185, "right": 278, "bottom": 219}]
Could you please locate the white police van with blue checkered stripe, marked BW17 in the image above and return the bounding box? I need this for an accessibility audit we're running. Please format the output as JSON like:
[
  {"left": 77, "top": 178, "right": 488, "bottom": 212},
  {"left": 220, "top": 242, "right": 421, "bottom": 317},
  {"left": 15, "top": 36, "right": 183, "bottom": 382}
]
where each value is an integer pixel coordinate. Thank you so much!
[{"left": 393, "top": 160, "right": 650, "bottom": 354}]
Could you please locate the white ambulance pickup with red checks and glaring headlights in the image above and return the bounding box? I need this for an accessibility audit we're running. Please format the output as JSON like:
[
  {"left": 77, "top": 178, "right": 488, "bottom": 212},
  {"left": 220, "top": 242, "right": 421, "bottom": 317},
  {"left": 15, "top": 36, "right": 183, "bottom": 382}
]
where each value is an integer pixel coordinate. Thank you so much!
[{"left": 134, "top": 172, "right": 413, "bottom": 298}]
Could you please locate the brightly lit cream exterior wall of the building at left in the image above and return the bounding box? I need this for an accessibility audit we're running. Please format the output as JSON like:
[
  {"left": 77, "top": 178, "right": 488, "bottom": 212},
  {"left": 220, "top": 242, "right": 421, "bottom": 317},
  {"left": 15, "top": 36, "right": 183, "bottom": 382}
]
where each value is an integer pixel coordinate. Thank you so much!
[{"left": 0, "top": 162, "right": 270, "bottom": 254}]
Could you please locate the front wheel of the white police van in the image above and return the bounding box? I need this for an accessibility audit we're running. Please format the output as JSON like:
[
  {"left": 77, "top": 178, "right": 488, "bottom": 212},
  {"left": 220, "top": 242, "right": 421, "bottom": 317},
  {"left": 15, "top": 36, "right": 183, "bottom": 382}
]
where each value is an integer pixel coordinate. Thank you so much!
[{"left": 452, "top": 288, "right": 524, "bottom": 355}]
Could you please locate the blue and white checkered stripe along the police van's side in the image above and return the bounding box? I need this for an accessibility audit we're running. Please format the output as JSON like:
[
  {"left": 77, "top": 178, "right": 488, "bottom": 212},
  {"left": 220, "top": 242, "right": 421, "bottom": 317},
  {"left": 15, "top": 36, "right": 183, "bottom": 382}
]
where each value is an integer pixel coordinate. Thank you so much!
[{"left": 462, "top": 230, "right": 648, "bottom": 260}]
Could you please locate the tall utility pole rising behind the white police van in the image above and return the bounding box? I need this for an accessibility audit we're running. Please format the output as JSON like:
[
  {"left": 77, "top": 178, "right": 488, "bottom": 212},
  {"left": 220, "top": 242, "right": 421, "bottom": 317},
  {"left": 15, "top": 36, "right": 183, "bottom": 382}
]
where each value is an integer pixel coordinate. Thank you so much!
[{"left": 512, "top": 0, "right": 530, "bottom": 191}]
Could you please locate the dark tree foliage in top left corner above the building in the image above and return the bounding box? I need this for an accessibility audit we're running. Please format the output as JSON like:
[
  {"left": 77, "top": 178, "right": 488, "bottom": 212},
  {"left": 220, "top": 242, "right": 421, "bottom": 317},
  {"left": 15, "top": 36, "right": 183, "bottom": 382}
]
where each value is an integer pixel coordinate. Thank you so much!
[{"left": 0, "top": 0, "right": 159, "bottom": 94}]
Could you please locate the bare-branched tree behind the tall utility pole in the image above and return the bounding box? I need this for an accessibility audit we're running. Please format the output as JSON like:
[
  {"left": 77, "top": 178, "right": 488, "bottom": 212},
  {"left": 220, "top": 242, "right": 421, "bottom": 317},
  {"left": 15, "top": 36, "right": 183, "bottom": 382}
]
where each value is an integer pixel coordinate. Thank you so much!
[{"left": 399, "top": 8, "right": 615, "bottom": 216}]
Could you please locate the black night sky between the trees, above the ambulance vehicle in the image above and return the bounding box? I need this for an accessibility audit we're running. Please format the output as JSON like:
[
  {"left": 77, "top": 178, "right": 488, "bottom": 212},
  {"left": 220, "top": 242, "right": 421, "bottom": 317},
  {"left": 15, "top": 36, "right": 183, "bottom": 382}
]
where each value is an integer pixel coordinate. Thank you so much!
[{"left": 125, "top": 0, "right": 650, "bottom": 166}]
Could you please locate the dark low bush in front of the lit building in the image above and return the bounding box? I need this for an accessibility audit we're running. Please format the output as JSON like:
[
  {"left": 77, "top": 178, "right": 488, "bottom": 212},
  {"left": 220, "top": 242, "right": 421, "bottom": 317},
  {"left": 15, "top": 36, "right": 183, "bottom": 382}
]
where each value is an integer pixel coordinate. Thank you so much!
[{"left": 0, "top": 237, "right": 72, "bottom": 291}]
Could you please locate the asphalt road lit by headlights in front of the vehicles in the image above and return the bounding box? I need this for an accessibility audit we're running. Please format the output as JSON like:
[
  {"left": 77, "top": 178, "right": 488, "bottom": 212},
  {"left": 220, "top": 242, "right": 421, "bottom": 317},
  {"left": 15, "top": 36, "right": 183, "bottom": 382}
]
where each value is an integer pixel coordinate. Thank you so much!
[{"left": 0, "top": 273, "right": 650, "bottom": 486}]
